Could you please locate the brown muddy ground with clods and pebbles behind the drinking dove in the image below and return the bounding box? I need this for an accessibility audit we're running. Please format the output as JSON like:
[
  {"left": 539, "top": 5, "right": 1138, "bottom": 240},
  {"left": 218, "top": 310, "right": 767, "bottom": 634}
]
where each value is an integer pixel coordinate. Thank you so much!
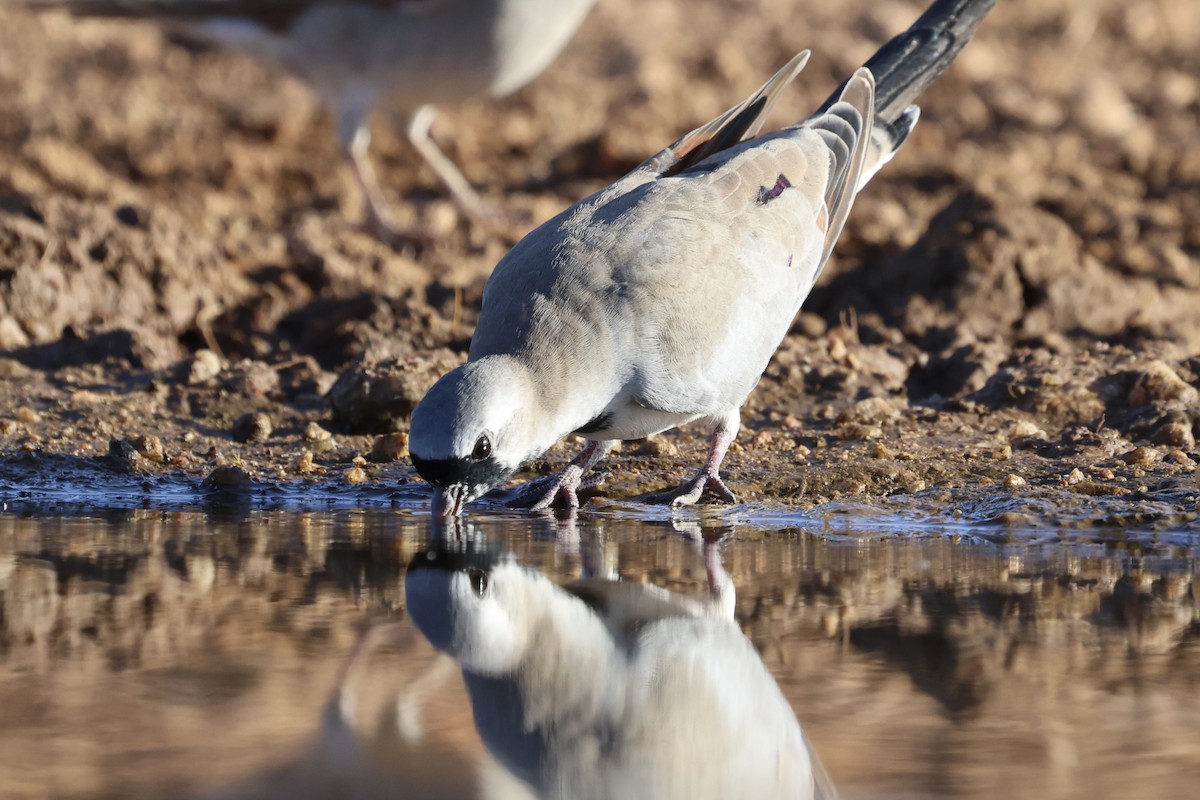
[{"left": 0, "top": 0, "right": 1200, "bottom": 527}]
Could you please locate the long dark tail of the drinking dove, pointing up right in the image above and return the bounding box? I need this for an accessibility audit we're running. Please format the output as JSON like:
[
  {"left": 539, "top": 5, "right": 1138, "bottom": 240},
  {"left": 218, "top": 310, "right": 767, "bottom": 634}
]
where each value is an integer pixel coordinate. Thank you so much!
[{"left": 821, "top": 0, "right": 996, "bottom": 184}]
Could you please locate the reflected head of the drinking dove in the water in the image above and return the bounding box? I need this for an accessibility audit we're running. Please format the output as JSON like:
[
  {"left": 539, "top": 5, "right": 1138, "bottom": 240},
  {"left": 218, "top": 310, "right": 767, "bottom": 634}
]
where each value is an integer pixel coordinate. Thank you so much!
[{"left": 404, "top": 549, "right": 545, "bottom": 675}]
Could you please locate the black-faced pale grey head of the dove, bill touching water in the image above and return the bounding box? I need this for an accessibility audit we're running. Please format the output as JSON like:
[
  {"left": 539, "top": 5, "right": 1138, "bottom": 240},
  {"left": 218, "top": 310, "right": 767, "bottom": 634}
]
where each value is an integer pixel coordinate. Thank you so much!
[{"left": 408, "top": 356, "right": 533, "bottom": 517}]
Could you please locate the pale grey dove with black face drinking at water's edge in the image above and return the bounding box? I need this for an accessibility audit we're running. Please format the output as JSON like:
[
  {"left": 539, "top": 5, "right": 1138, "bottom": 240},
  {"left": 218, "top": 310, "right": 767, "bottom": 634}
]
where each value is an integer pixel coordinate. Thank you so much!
[{"left": 409, "top": 0, "right": 996, "bottom": 517}]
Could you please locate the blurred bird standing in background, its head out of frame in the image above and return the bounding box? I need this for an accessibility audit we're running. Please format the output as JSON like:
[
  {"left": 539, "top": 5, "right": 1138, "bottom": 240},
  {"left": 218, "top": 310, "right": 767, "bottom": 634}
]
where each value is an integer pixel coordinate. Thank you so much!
[{"left": 16, "top": 0, "right": 595, "bottom": 240}]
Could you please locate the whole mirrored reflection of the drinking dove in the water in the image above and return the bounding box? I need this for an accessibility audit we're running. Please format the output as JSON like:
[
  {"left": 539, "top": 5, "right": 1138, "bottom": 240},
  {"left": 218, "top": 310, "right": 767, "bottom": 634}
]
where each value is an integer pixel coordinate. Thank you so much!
[{"left": 404, "top": 532, "right": 835, "bottom": 800}]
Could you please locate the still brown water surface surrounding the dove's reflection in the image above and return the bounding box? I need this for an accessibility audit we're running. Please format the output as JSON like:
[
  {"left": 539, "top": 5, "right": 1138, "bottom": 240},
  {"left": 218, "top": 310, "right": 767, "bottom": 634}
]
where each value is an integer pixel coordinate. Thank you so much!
[{"left": 0, "top": 504, "right": 1200, "bottom": 799}]
